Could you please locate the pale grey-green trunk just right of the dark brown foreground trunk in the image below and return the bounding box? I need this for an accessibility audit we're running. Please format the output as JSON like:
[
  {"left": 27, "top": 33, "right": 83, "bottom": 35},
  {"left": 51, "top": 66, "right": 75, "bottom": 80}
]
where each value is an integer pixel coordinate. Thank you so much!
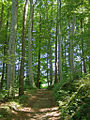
[{"left": 28, "top": 0, "right": 35, "bottom": 87}]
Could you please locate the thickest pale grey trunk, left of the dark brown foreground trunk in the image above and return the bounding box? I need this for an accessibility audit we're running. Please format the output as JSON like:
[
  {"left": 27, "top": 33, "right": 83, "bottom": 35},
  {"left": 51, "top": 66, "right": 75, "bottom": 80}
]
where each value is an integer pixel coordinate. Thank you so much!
[{"left": 7, "top": 0, "right": 18, "bottom": 97}]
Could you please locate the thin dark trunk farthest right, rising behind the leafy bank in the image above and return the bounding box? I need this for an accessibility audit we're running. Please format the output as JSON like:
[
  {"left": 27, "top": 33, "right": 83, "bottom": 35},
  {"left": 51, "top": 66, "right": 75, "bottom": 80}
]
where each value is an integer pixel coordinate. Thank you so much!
[{"left": 81, "top": 18, "right": 86, "bottom": 73}]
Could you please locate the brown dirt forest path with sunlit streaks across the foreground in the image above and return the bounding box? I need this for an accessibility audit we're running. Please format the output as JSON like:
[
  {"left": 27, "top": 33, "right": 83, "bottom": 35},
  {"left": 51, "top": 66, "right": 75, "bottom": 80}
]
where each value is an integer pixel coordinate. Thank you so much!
[{"left": 0, "top": 89, "right": 60, "bottom": 120}]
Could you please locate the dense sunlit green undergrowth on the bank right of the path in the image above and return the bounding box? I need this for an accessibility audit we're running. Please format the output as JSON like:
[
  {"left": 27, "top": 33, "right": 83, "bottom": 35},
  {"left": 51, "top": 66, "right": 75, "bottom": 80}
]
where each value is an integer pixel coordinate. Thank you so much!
[{"left": 53, "top": 75, "right": 90, "bottom": 120}]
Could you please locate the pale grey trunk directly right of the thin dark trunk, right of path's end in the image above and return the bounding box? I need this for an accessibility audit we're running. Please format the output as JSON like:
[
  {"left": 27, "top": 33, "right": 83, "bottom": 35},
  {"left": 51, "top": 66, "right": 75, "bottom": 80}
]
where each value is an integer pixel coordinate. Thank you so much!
[{"left": 57, "top": 0, "right": 62, "bottom": 81}]
